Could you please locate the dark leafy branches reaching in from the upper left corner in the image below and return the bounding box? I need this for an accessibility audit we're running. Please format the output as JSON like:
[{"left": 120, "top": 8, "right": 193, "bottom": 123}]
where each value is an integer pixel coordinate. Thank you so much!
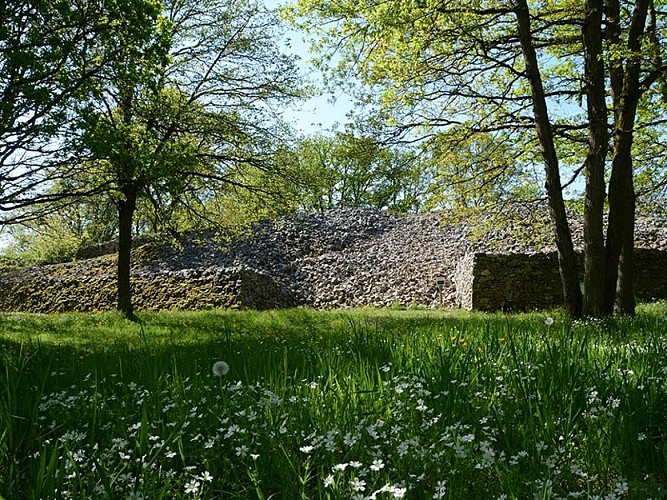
[{"left": 0, "top": 0, "right": 166, "bottom": 219}]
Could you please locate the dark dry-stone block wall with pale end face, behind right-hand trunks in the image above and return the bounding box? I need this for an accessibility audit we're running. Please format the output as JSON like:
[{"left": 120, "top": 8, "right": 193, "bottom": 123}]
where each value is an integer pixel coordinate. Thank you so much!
[{"left": 454, "top": 249, "right": 667, "bottom": 311}]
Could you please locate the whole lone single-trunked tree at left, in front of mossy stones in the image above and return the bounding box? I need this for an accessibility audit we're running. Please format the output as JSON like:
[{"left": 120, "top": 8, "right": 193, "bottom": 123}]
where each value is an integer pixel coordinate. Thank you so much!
[{"left": 64, "top": 0, "right": 298, "bottom": 318}]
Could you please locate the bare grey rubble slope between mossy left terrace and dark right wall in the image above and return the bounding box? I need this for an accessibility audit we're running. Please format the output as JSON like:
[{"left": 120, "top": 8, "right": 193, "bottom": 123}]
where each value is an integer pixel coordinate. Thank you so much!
[{"left": 142, "top": 209, "right": 474, "bottom": 308}]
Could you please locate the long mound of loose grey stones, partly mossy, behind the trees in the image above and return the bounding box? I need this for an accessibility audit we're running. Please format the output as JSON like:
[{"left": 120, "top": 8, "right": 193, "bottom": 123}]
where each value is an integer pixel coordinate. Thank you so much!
[{"left": 0, "top": 204, "right": 667, "bottom": 312}]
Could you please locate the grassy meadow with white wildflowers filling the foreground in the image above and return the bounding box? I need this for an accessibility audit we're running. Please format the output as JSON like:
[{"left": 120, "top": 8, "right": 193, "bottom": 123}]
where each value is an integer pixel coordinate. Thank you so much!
[{"left": 0, "top": 304, "right": 667, "bottom": 500}]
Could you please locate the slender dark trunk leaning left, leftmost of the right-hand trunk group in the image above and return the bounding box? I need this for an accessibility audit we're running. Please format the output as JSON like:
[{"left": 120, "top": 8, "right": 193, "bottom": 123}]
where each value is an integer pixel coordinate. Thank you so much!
[{"left": 514, "top": 0, "right": 582, "bottom": 318}]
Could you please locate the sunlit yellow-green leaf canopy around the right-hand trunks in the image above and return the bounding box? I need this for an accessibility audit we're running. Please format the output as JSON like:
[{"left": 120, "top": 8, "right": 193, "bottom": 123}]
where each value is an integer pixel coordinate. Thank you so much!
[{"left": 292, "top": 0, "right": 666, "bottom": 204}]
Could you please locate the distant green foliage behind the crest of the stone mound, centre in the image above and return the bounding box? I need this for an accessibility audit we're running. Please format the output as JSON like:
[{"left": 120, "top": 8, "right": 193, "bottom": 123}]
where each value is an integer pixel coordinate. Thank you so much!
[{"left": 201, "top": 119, "right": 427, "bottom": 230}]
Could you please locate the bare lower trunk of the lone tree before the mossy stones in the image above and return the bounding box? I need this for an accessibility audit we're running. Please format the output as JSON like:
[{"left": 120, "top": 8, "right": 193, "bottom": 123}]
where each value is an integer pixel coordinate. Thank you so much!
[{"left": 117, "top": 185, "right": 137, "bottom": 319}]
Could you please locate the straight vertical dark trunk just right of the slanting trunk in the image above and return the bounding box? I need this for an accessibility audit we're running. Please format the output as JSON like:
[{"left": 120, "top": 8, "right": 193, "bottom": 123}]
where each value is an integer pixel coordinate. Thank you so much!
[{"left": 582, "top": 0, "right": 609, "bottom": 317}]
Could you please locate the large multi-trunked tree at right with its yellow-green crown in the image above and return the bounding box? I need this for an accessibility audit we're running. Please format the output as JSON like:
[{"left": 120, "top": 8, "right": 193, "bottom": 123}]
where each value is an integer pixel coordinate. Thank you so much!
[{"left": 295, "top": 0, "right": 665, "bottom": 317}]
